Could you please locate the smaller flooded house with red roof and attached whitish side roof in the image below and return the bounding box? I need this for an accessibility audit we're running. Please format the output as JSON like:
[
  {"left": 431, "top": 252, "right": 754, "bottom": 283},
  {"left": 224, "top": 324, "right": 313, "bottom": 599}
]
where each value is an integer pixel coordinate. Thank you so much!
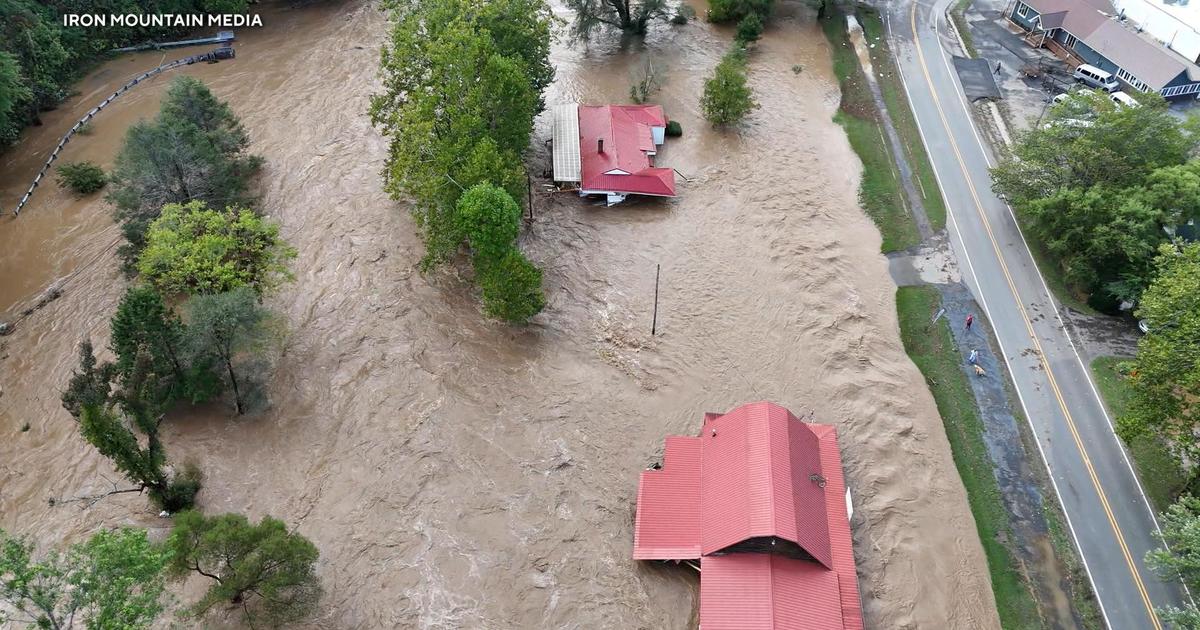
[{"left": 553, "top": 103, "right": 676, "bottom": 205}]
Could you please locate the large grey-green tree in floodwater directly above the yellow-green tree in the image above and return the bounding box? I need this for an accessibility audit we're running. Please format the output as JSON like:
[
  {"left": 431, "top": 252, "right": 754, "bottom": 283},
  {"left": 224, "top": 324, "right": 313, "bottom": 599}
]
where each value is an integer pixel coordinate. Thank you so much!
[{"left": 108, "top": 77, "right": 262, "bottom": 269}]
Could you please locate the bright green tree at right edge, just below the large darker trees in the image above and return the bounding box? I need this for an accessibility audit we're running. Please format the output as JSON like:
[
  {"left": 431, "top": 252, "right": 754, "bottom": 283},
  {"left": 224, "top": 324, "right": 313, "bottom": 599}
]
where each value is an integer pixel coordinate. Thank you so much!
[{"left": 1117, "top": 244, "right": 1200, "bottom": 456}]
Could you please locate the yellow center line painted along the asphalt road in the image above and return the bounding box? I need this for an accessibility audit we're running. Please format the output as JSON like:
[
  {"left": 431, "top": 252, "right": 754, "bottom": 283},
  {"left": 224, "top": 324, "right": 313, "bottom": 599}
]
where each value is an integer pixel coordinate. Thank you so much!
[{"left": 910, "top": 4, "right": 1163, "bottom": 630}]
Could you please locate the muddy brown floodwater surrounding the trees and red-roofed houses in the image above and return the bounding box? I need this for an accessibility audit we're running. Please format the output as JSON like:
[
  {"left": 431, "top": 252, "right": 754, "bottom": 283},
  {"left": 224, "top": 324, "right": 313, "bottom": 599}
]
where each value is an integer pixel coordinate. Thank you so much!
[{"left": 0, "top": 0, "right": 998, "bottom": 629}]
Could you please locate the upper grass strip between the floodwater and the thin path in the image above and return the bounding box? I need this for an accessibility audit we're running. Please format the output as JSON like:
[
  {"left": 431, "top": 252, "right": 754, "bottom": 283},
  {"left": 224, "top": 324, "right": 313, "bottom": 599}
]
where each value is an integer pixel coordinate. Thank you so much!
[{"left": 821, "top": 11, "right": 921, "bottom": 253}]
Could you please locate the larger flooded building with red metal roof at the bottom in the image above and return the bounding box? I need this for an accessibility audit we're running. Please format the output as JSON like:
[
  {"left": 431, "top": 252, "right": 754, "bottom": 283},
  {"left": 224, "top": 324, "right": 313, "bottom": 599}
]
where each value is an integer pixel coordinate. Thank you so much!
[{"left": 634, "top": 402, "right": 863, "bottom": 630}]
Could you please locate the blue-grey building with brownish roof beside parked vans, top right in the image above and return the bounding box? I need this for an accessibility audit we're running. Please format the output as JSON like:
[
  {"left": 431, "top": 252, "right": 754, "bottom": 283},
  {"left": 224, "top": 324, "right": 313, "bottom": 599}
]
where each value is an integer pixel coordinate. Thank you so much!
[{"left": 1008, "top": 0, "right": 1200, "bottom": 98}]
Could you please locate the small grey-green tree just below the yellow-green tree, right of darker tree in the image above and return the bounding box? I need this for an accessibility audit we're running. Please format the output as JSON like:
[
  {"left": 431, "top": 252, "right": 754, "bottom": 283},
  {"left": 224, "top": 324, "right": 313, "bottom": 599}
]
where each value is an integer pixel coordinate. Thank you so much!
[{"left": 186, "top": 287, "right": 270, "bottom": 414}]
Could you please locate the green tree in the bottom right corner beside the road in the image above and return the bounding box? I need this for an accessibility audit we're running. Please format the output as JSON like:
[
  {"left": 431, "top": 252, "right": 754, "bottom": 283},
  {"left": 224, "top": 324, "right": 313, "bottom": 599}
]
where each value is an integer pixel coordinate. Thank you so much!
[{"left": 1146, "top": 494, "right": 1200, "bottom": 628}]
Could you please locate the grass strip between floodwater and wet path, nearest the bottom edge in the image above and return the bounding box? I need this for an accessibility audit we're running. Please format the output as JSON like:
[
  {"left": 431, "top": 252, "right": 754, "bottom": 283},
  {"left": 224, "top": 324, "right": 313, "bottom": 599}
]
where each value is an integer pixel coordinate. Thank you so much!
[{"left": 896, "top": 287, "right": 1042, "bottom": 629}]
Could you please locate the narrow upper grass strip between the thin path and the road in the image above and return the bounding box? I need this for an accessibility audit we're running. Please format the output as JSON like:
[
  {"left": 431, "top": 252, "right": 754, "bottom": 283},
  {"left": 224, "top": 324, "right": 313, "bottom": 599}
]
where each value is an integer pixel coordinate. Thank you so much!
[{"left": 858, "top": 7, "right": 946, "bottom": 232}]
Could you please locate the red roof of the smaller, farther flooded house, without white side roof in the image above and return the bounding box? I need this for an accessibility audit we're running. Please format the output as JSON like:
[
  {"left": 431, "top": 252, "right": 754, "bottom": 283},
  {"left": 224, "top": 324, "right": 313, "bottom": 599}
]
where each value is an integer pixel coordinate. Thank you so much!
[{"left": 580, "top": 106, "right": 674, "bottom": 197}]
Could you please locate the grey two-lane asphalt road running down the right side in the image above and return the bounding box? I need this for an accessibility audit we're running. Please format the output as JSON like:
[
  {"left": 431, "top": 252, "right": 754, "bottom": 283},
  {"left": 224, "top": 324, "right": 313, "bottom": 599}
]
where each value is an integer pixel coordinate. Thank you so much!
[{"left": 887, "top": 0, "right": 1183, "bottom": 630}]
